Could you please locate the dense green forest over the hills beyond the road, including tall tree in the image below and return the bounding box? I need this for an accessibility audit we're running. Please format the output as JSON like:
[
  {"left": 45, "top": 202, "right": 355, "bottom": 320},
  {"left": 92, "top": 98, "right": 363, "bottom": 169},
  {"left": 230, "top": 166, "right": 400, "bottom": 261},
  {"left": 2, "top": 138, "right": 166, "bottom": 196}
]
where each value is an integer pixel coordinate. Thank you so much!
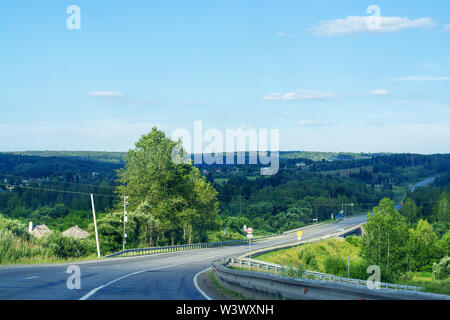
[{"left": 0, "top": 134, "right": 450, "bottom": 252}]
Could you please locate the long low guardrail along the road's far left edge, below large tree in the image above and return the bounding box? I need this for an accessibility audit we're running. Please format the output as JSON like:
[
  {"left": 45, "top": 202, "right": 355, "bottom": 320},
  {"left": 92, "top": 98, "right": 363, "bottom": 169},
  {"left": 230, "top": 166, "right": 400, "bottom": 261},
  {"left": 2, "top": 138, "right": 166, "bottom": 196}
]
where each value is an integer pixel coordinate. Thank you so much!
[{"left": 105, "top": 215, "right": 338, "bottom": 258}]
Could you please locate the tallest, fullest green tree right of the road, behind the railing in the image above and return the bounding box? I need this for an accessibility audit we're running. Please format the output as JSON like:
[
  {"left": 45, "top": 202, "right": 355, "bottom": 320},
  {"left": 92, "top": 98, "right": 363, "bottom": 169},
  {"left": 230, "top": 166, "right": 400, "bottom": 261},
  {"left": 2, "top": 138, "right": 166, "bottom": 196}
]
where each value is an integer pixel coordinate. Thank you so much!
[{"left": 361, "top": 198, "right": 408, "bottom": 279}]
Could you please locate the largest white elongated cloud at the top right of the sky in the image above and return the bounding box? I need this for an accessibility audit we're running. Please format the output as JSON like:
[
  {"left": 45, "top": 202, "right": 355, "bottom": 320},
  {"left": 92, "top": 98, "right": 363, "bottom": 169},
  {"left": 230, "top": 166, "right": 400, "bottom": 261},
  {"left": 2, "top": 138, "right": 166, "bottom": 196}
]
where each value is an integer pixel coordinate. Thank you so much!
[{"left": 309, "top": 16, "right": 436, "bottom": 36}]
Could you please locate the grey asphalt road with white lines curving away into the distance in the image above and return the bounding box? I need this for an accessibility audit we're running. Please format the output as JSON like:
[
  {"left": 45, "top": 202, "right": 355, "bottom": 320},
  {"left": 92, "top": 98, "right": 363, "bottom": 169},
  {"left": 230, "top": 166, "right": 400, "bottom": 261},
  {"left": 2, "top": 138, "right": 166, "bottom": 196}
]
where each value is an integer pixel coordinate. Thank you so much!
[{"left": 0, "top": 215, "right": 366, "bottom": 300}]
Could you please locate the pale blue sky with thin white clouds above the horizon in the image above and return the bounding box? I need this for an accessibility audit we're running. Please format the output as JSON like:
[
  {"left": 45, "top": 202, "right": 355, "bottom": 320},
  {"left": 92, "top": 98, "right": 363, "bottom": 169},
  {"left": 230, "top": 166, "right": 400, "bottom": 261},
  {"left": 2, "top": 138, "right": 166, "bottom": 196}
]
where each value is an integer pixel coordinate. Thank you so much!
[{"left": 0, "top": 0, "right": 450, "bottom": 153}]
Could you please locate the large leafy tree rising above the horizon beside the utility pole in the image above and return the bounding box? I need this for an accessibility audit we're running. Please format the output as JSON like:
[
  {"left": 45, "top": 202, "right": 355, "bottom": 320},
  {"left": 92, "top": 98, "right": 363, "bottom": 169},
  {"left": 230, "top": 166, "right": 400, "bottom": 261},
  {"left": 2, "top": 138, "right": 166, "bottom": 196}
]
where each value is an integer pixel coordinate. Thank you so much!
[{"left": 117, "top": 127, "right": 218, "bottom": 245}]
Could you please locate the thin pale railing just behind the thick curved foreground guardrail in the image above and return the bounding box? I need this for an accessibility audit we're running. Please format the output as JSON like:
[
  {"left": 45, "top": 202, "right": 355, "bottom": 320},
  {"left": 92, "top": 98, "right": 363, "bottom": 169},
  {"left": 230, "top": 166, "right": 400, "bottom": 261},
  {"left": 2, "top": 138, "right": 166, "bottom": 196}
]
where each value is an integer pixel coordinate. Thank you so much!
[{"left": 225, "top": 258, "right": 423, "bottom": 292}]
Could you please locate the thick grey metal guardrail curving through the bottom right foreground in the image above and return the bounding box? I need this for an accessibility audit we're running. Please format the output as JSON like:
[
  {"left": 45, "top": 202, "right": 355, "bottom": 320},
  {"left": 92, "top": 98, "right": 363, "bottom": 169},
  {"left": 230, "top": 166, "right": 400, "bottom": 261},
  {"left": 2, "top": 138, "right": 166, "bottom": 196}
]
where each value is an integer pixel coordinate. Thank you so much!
[{"left": 212, "top": 259, "right": 450, "bottom": 300}]
